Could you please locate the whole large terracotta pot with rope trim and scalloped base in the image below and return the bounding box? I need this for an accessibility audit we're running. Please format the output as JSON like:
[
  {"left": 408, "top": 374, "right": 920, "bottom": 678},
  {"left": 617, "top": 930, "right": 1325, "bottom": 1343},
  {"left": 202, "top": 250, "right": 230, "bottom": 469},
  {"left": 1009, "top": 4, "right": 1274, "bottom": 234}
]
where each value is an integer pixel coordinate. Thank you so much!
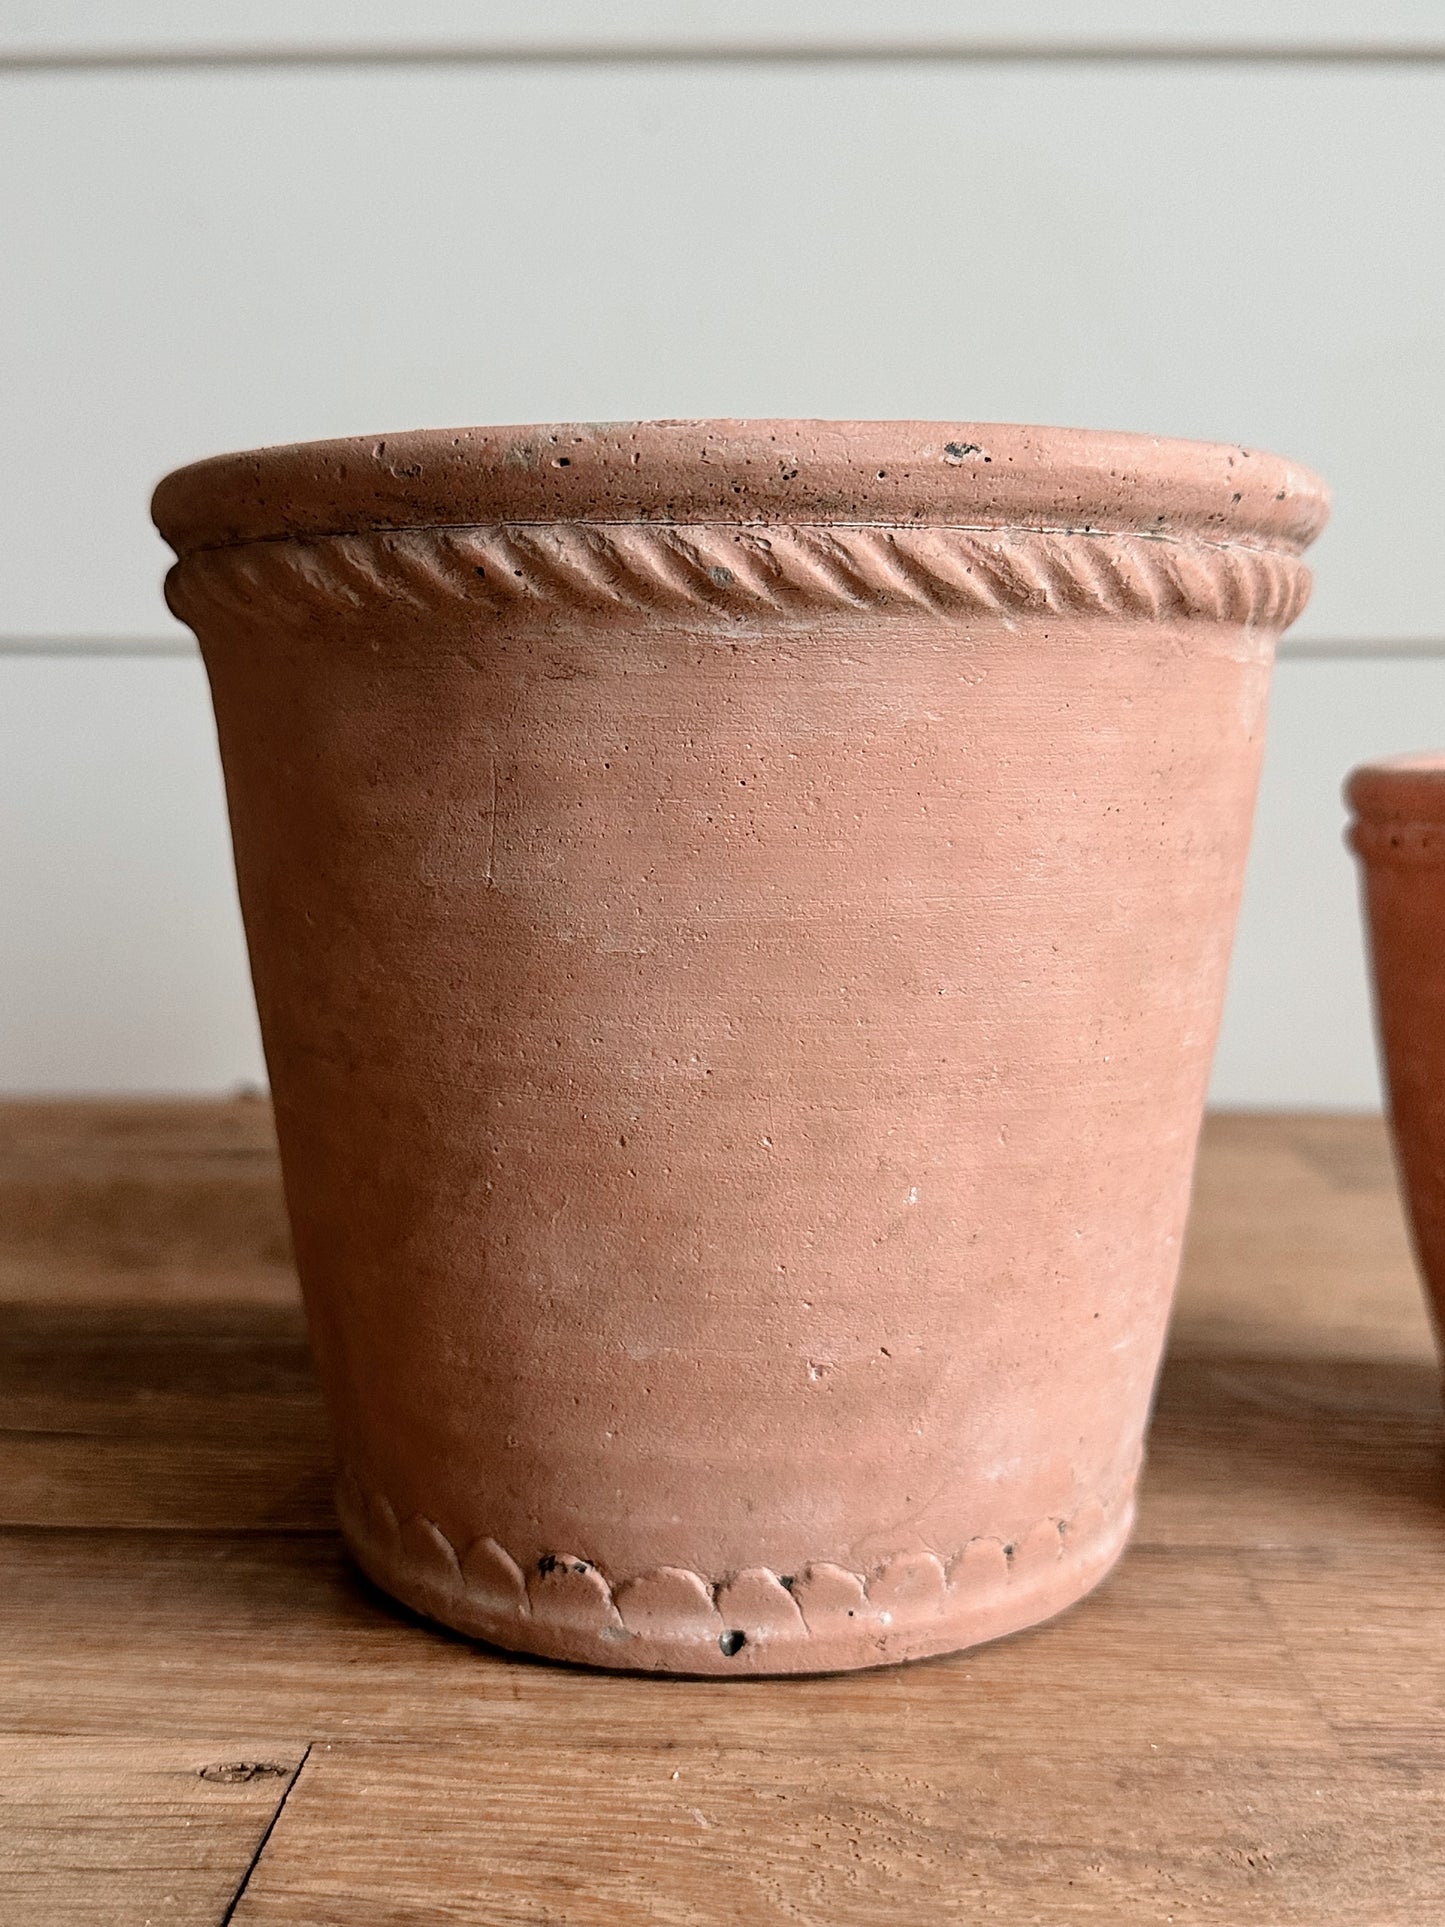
[{"left": 156, "top": 422, "right": 1326, "bottom": 1675}]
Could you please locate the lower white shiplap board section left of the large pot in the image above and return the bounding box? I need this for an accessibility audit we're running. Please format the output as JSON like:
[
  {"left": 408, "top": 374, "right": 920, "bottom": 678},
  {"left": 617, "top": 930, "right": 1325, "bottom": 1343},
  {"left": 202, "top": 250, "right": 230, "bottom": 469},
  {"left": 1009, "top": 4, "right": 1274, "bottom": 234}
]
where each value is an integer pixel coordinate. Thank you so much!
[{"left": 0, "top": 657, "right": 264, "bottom": 1095}]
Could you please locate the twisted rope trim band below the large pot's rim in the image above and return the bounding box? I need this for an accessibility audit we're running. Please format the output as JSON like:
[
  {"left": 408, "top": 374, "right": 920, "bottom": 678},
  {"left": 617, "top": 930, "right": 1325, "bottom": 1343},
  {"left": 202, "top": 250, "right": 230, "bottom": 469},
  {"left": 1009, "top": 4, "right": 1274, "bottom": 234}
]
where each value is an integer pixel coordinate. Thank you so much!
[{"left": 166, "top": 522, "right": 1310, "bottom": 630}]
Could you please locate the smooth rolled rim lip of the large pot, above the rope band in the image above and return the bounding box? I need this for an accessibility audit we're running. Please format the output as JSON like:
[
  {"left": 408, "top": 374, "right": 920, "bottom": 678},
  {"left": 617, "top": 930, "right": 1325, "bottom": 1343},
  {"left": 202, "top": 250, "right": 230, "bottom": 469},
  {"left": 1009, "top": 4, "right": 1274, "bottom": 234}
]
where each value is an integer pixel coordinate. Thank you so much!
[{"left": 150, "top": 418, "right": 1329, "bottom": 557}]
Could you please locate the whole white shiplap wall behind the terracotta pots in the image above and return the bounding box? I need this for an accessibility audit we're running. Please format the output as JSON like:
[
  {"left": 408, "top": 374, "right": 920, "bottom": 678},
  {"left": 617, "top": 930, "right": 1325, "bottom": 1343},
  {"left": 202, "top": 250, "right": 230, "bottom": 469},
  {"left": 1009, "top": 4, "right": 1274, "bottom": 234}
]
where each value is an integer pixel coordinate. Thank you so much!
[{"left": 0, "top": 0, "right": 1445, "bottom": 1106}]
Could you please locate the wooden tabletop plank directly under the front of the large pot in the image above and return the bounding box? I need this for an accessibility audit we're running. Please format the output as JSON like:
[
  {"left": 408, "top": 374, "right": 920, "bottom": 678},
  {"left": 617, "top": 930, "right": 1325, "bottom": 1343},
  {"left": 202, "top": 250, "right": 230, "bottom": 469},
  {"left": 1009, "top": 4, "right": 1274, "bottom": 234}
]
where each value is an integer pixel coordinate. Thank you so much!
[{"left": 0, "top": 1532, "right": 1349, "bottom": 1757}]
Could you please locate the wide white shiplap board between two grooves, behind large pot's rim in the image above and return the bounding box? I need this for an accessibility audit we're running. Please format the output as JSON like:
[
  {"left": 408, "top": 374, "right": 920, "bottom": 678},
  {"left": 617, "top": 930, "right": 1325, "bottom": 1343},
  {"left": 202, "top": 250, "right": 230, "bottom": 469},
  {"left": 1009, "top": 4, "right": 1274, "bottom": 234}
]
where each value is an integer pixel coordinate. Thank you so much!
[{"left": 0, "top": 66, "right": 1445, "bottom": 636}]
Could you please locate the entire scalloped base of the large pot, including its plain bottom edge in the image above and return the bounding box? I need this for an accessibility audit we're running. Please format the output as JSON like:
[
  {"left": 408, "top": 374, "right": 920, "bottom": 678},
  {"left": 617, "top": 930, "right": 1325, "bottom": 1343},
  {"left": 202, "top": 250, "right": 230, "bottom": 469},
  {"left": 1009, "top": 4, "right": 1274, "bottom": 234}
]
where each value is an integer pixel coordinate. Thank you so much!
[{"left": 337, "top": 1474, "right": 1135, "bottom": 1678}]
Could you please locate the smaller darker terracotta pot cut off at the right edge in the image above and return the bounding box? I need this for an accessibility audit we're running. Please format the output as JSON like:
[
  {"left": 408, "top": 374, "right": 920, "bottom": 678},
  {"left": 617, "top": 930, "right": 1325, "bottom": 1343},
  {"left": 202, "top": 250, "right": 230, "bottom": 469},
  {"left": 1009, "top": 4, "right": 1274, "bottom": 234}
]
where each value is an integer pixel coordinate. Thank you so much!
[{"left": 1345, "top": 752, "right": 1445, "bottom": 1364}]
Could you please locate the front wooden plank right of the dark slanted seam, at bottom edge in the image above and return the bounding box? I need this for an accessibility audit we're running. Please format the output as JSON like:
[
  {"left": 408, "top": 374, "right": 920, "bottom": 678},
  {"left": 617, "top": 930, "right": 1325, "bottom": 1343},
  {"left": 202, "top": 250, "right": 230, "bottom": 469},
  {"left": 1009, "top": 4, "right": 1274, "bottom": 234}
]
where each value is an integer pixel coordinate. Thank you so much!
[{"left": 226, "top": 1723, "right": 1445, "bottom": 1927}]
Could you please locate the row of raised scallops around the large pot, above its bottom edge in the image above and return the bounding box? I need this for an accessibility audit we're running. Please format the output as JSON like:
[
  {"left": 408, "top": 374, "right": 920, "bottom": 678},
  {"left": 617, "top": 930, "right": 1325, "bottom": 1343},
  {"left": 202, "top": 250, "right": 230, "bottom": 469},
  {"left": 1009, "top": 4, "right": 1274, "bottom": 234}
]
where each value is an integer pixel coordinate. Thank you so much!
[{"left": 337, "top": 1472, "right": 1110, "bottom": 1657}]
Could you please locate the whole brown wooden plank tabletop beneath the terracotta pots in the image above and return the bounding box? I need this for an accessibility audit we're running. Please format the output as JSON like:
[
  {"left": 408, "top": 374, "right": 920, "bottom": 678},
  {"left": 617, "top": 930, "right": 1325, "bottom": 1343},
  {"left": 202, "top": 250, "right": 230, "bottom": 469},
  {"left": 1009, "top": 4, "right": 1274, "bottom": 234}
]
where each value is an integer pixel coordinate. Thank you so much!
[{"left": 0, "top": 1100, "right": 1445, "bottom": 1927}]
